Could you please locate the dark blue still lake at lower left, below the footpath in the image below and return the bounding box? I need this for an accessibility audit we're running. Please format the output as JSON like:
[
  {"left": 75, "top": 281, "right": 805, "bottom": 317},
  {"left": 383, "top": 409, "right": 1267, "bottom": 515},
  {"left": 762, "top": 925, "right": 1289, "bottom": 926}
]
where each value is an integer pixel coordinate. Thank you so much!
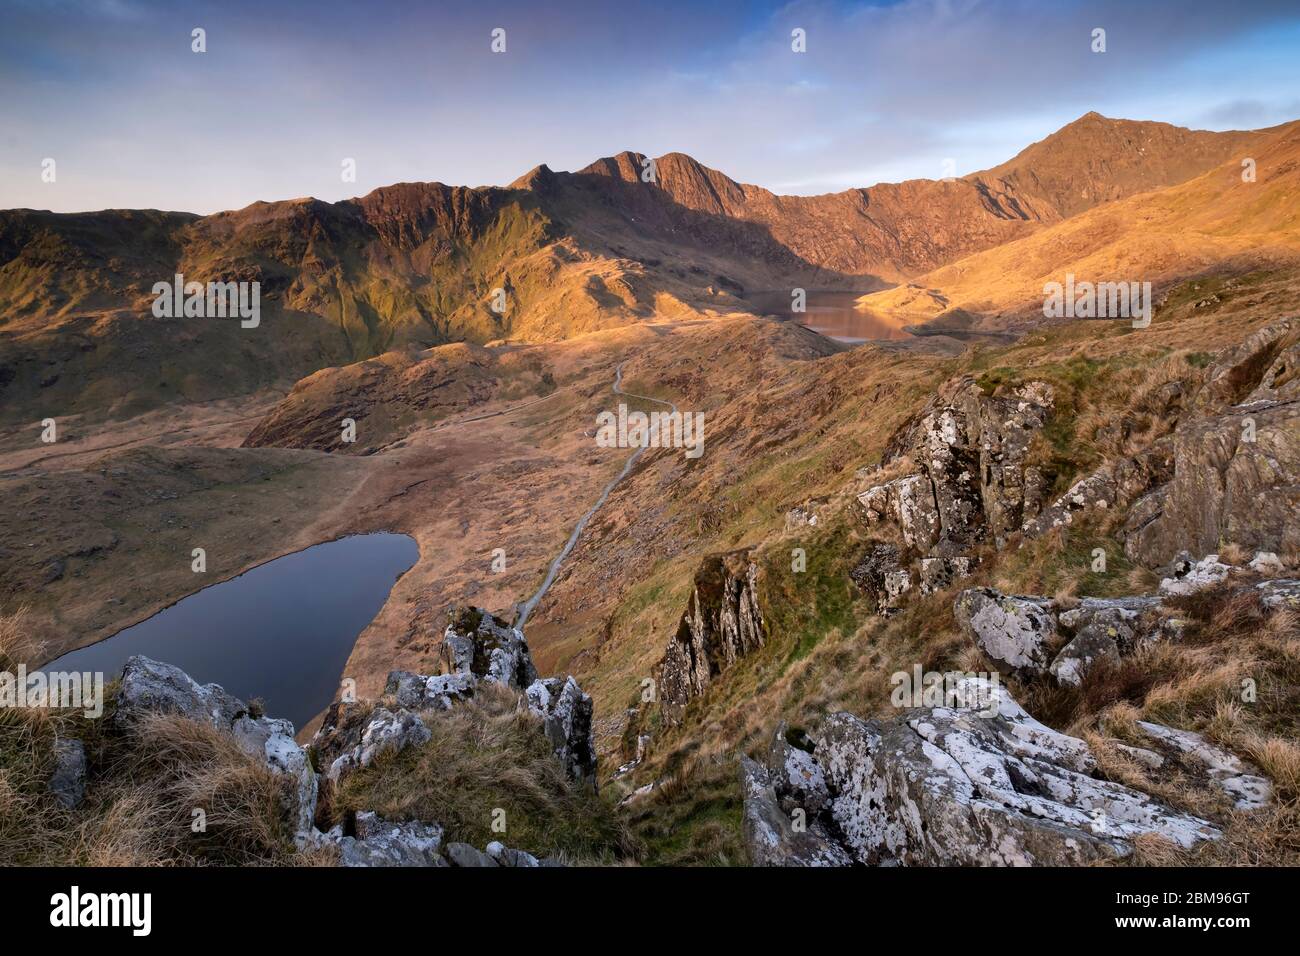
[{"left": 42, "top": 533, "right": 420, "bottom": 728}]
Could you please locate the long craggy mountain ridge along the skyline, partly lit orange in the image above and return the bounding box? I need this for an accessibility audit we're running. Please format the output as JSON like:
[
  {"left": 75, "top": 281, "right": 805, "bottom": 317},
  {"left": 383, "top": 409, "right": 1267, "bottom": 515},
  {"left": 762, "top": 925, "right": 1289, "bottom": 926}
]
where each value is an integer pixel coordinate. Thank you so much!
[{"left": 0, "top": 114, "right": 1279, "bottom": 420}]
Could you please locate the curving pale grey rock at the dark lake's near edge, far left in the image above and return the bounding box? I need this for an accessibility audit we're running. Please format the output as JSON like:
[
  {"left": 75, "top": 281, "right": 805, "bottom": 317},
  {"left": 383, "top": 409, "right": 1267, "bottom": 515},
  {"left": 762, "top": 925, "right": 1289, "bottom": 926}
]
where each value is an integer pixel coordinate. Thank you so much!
[{"left": 114, "top": 657, "right": 317, "bottom": 839}]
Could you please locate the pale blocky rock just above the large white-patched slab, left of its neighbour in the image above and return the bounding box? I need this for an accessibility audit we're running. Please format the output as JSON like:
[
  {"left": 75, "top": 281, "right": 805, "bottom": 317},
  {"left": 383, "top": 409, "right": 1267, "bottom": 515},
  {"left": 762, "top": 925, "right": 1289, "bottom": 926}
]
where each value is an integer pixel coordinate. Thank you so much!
[{"left": 953, "top": 588, "right": 1056, "bottom": 676}]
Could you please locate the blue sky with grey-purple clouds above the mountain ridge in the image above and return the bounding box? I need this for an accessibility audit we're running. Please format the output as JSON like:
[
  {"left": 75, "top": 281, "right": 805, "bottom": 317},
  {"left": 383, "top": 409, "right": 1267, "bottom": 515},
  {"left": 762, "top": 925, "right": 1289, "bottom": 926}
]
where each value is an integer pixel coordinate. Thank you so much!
[{"left": 0, "top": 0, "right": 1300, "bottom": 213}]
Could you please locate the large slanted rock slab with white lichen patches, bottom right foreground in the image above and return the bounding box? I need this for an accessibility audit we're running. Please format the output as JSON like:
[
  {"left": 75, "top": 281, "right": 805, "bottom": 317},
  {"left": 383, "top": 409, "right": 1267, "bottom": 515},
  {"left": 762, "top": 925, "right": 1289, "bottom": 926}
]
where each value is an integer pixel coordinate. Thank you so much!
[{"left": 742, "top": 678, "right": 1219, "bottom": 866}]
